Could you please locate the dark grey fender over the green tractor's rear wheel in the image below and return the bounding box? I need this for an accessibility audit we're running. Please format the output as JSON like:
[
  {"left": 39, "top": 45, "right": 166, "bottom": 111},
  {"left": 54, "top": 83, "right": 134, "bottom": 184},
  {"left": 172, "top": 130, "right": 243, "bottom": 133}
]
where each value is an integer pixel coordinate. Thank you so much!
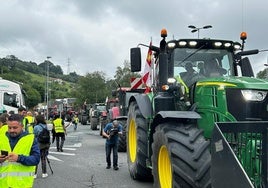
[{"left": 129, "top": 94, "right": 153, "bottom": 119}]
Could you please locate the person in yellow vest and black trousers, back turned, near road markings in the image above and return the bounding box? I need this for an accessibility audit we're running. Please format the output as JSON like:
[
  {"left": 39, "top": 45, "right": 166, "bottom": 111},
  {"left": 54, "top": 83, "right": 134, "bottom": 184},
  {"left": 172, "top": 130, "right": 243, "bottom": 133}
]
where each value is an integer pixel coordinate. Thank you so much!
[{"left": 53, "top": 114, "right": 66, "bottom": 152}]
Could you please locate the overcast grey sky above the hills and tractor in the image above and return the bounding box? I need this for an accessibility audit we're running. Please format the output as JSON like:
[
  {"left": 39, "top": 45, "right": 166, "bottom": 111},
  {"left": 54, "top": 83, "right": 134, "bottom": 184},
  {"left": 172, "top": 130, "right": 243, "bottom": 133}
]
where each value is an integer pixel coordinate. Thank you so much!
[{"left": 0, "top": 0, "right": 268, "bottom": 78}]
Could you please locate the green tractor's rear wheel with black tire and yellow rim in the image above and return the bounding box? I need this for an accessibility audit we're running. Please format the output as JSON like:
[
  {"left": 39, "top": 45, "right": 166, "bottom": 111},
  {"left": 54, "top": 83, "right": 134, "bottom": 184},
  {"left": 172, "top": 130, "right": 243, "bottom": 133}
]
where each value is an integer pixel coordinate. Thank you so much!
[{"left": 126, "top": 102, "right": 152, "bottom": 180}]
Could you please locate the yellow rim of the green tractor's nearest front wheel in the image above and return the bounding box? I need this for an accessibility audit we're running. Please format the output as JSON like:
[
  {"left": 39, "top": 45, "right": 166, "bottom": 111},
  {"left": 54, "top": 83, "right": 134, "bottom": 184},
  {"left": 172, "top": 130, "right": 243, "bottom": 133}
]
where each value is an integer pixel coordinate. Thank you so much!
[{"left": 158, "top": 146, "right": 172, "bottom": 188}]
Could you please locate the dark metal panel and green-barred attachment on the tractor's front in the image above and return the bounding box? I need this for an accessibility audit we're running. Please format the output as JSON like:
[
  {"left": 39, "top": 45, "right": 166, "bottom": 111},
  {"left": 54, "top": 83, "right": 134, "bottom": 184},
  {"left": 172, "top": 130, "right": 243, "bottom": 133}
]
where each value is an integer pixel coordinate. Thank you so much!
[{"left": 211, "top": 121, "right": 268, "bottom": 188}]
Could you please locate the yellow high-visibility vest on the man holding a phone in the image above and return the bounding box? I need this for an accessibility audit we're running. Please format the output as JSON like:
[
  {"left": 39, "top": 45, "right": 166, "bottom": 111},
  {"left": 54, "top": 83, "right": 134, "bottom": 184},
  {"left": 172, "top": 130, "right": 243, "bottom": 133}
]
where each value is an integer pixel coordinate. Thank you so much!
[{"left": 0, "top": 134, "right": 35, "bottom": 188}]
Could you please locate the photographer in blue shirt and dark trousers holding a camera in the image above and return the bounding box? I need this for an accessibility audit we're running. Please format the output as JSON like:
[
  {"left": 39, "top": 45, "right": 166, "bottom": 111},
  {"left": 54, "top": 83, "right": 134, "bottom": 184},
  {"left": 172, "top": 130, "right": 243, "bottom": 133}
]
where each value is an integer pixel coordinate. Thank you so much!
[{"left": 102, "top": 120, "right": 123, "bottom": 170}]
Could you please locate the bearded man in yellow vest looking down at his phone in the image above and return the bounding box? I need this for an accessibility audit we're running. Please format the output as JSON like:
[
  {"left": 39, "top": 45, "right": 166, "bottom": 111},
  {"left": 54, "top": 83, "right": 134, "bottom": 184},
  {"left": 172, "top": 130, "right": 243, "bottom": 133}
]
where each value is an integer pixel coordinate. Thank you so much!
[{"left": 0, "top": 114, "right": 40, "bottom": 188}]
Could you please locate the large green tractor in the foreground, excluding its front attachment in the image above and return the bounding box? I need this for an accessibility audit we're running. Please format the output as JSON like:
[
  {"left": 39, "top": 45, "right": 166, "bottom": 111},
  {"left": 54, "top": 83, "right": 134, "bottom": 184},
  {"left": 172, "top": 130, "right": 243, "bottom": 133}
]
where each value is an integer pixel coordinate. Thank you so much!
[{"left": 126, "top": 29, "right": 268, "bottom": 188}]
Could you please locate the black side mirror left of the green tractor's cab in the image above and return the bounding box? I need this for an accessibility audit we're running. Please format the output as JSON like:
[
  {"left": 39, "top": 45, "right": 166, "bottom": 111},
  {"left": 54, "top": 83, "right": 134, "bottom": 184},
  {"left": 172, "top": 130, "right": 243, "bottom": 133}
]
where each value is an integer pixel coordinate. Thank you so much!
[{"left": 130, "top": 47, "right": 141, "bottom": 72}]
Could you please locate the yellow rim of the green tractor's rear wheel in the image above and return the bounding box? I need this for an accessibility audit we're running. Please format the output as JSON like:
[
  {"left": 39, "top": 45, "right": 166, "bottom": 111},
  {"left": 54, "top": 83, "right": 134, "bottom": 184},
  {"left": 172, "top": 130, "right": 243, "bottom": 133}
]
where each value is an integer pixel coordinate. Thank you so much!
[{"left": 128, "top": 119, "right": 137, "bottom": 163}]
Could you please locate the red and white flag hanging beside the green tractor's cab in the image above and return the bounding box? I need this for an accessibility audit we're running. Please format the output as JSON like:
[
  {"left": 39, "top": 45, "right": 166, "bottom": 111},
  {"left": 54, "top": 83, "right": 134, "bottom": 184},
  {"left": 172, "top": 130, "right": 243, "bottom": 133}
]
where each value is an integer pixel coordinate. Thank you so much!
[{"left": 142, "top": 41, "right": 153, "bottom": 88}]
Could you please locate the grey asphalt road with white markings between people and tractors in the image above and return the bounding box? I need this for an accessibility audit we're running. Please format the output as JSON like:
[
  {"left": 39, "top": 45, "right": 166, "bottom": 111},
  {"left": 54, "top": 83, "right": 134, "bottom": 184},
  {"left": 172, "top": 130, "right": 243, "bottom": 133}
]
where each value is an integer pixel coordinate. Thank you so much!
[{"left": 34, "top": 124, "right": 153, "bottom": 188}]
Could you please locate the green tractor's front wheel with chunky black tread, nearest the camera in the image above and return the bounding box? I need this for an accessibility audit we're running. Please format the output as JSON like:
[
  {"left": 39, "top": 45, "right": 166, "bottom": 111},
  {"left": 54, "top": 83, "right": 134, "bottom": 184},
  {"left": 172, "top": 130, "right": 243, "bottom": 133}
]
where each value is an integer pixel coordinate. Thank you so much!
[{"left": 152, "top": 122, "right": 211, "bottom": 188}]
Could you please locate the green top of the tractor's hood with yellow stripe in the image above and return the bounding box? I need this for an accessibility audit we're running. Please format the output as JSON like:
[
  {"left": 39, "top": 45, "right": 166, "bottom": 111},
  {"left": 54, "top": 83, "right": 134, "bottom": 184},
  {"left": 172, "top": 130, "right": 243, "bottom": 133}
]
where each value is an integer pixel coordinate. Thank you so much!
[{"left": 197, "top": 76, "right": 268, "bottom": 90}]
